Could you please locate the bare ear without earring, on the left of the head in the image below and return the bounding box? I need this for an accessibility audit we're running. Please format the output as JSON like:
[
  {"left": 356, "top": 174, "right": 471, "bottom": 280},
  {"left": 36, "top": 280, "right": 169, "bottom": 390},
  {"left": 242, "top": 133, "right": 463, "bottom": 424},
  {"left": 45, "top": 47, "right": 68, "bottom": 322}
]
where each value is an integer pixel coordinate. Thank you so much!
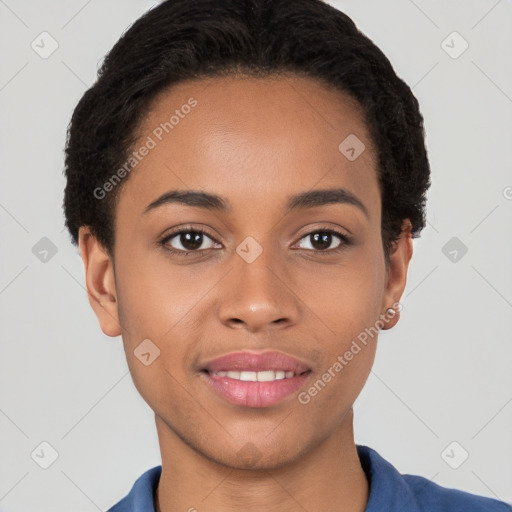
[{"left": 78, "top": 226, "right": 121, "bottom": 337}]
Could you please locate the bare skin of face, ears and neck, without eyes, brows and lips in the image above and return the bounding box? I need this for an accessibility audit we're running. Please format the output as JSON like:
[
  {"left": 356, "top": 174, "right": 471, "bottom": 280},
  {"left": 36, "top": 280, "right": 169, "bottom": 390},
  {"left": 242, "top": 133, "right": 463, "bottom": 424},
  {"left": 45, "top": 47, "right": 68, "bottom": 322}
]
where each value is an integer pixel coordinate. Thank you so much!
[{"left": 79, "top": 76, "right": 412, "bottom": 512}]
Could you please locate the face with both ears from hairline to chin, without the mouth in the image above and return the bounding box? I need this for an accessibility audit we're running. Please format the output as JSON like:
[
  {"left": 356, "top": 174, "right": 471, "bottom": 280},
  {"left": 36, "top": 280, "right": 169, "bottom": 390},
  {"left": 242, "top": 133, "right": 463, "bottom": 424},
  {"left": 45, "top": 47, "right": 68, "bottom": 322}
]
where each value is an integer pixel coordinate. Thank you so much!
[{"left": 81, "top": 77, "right": 411, "bottom": 468}]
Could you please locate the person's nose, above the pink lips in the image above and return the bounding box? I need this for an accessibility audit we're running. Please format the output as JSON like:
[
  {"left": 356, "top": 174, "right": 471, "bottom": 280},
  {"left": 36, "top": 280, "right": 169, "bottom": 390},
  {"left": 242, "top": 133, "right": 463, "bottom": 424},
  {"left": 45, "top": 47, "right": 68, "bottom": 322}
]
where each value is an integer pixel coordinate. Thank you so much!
[{"left": 219, "top": 251, "right": 300, "bottom": 333}]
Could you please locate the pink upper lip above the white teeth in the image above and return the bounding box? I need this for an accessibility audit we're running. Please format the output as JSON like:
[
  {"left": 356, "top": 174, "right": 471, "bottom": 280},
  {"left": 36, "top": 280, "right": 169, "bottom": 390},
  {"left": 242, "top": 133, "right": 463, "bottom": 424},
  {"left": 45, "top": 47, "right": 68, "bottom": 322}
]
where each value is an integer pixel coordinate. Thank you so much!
[{"left": 200, "top": 350, "right": 311, "bottom": 374}]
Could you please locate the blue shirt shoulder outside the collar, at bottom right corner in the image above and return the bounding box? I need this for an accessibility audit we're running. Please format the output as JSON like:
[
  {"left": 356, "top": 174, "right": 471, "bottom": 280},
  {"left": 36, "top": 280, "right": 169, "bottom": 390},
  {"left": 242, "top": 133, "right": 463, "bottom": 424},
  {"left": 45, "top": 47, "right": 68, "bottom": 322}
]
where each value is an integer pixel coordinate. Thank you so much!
[{"left": 402, "top": 475, "right": 512, "bottom": 512}]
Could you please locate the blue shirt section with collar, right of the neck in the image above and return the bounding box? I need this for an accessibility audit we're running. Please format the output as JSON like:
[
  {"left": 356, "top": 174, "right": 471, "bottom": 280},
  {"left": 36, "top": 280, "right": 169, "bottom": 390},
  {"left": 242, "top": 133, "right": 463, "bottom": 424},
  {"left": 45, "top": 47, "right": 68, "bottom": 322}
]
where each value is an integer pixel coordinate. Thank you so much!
[{"left": 356, "top": 445, "right": 512, "bottom": 512}]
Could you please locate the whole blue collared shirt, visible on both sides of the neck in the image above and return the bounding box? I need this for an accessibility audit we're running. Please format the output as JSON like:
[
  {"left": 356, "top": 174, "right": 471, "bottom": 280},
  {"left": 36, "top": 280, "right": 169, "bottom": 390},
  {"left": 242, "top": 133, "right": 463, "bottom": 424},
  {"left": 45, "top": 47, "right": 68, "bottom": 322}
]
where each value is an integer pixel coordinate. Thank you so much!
[{"left": 107, "top": 445, "right": 512, "bottom": 512}]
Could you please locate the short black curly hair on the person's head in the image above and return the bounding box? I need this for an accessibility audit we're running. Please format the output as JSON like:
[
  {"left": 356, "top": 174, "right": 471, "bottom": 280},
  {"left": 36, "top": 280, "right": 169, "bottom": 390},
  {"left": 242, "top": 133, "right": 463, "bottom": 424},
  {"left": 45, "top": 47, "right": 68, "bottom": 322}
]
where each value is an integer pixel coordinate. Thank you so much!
[{"left": 63, "top": 0, "right": 430, "bottom": 262}]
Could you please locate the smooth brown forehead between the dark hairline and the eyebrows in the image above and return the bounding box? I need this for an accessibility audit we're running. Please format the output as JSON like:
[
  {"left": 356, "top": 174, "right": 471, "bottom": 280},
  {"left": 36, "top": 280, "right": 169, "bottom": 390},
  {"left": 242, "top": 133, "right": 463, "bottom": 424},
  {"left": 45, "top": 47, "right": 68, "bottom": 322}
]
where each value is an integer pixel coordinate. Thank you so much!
[{"left": 118, "top": 75, "right": 378, "bottom": 220}]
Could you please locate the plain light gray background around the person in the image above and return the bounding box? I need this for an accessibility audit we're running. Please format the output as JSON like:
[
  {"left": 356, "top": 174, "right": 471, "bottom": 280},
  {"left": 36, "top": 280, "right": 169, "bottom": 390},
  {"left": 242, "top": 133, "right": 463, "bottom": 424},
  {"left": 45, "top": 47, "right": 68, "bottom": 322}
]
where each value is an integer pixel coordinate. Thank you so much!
[{"left": 0, "top": 0, "right": 512, "bottom": 512}]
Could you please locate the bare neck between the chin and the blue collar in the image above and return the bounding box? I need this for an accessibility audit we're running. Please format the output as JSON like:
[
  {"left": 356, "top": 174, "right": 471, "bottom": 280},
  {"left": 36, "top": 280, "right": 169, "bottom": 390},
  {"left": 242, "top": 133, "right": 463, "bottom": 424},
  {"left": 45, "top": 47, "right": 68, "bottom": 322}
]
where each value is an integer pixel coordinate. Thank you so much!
[{"left": 155, "top": 409, "right": 369, "bottom": 512}]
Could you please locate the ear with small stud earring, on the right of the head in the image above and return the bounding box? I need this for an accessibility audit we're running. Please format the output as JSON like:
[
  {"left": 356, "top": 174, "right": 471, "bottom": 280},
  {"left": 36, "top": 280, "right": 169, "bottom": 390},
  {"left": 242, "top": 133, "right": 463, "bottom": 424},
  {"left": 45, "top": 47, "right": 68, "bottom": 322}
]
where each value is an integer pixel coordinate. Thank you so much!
[{"left": 382, "top": 219, "right": 413, "bottom": 330}]
